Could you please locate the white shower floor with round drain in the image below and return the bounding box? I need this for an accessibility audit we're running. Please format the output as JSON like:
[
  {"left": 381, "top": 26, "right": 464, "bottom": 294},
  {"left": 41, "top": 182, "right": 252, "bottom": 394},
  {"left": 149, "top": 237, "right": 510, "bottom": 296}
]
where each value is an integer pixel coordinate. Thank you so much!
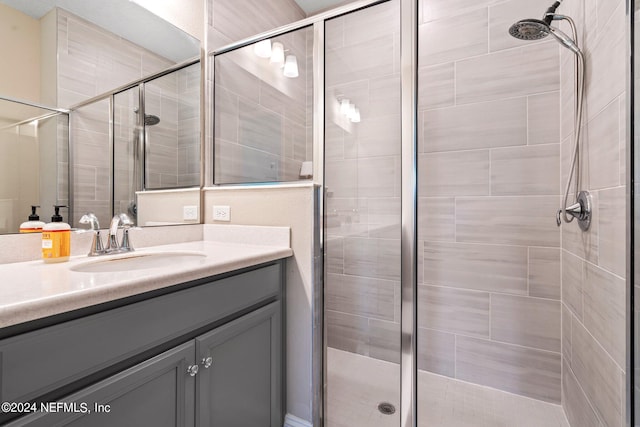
[{"left": 326, "top": 348, "right": 569, "bottom": 427}]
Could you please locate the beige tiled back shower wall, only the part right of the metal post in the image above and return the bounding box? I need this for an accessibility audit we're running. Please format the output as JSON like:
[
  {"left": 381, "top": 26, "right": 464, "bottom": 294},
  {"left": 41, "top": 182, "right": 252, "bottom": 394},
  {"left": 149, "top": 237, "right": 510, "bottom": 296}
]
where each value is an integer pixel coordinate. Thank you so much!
[{"left": 418, "top": 0, "right": 562, "bottom": 403}]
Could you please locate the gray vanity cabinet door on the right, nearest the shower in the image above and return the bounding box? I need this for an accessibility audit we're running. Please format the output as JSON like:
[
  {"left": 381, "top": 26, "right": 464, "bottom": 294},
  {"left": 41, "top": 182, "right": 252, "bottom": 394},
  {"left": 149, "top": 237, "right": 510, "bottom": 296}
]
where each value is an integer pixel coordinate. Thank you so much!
[{"left": 196, "top": 302, "right": 282, "bottom": 427}]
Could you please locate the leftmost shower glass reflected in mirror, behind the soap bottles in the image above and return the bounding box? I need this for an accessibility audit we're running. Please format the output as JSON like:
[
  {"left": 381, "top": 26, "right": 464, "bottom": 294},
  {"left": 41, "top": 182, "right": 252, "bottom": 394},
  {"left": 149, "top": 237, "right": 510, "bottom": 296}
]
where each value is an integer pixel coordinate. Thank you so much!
[{"left": 0, "top": 99, "right": 69, "bottom": 234}]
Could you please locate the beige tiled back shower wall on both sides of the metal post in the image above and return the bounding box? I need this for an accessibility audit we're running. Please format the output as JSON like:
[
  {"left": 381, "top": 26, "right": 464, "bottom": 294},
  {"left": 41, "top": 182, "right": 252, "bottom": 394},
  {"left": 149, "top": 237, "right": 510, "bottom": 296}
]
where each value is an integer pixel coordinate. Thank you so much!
[{"left": 326, "top": 0, "right": 561, "bottom": 403}]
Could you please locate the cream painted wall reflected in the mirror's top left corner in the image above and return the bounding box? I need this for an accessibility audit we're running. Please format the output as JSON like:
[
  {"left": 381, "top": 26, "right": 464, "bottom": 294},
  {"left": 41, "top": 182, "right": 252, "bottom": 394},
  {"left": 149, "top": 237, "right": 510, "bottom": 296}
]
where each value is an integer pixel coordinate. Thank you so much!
[{"left": 0, "top": 4, "right": 41, "bottom": 103}]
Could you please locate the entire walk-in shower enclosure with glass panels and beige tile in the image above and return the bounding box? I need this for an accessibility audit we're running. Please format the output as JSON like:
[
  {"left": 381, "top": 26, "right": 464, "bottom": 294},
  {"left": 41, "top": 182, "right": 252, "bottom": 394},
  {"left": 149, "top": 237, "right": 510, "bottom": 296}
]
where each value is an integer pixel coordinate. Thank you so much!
[{"left": 215, "top": 0, "right": 630, "bottom": 427}]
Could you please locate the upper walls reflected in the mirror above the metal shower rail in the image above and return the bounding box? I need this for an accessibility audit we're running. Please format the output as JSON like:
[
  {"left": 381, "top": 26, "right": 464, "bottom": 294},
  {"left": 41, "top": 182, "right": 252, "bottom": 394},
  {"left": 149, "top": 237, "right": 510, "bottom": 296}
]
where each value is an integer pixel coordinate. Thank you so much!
[{"left": 0, "top": 0, "right": 200, "bottom": 108}]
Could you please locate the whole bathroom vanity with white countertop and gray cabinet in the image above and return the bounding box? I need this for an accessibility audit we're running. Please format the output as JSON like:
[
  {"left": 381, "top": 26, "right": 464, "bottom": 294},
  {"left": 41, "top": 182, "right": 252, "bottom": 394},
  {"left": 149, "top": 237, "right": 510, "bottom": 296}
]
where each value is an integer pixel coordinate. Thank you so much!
[{"left": 0, "top": 229, "right": 292, "bottom": 427}]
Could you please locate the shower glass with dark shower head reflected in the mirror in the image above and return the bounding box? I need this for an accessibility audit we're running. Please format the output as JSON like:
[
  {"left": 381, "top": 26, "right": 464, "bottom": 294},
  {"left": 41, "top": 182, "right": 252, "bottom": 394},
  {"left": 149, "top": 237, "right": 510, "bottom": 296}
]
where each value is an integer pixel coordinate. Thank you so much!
[{"left": 113, "top": 62, "right": 200, "bottom": 226}]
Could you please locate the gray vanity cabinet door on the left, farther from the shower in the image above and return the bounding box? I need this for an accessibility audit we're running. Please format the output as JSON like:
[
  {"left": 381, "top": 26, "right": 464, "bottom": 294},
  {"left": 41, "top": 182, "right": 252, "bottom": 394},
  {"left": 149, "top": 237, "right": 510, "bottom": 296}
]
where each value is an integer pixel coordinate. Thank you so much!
[{"left": 9, "top": 341, "right": 195, "bottom": 427}]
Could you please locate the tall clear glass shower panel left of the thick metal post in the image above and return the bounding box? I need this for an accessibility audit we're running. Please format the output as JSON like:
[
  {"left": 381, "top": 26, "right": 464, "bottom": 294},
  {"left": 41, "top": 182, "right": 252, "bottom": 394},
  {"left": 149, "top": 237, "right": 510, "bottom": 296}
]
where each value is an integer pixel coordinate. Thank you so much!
[{"left": 324, "top": 0, "right": 401, "bottom": 427}]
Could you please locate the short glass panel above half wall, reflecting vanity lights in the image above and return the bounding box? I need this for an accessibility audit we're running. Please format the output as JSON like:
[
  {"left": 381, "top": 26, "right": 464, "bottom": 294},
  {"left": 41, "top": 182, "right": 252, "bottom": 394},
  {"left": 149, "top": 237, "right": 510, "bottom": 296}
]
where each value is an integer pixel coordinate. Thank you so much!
[{"left": 214, "top": 27, "right": 313, "bottom": 184}]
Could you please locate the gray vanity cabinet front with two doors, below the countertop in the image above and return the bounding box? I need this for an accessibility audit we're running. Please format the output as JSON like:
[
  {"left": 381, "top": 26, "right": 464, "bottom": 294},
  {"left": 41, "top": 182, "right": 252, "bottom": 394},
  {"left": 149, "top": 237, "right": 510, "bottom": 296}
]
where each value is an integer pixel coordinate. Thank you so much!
[{"left": 0, "top": 262, "right": 283, "bottom": 427}]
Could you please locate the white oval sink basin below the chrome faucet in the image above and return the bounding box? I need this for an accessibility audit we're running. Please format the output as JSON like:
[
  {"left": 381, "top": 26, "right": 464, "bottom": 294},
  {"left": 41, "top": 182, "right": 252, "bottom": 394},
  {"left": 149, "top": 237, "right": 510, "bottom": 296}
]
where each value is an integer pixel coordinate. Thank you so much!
[{"left": 70, "top": 252, "right": 206, "bottom": 273}]
